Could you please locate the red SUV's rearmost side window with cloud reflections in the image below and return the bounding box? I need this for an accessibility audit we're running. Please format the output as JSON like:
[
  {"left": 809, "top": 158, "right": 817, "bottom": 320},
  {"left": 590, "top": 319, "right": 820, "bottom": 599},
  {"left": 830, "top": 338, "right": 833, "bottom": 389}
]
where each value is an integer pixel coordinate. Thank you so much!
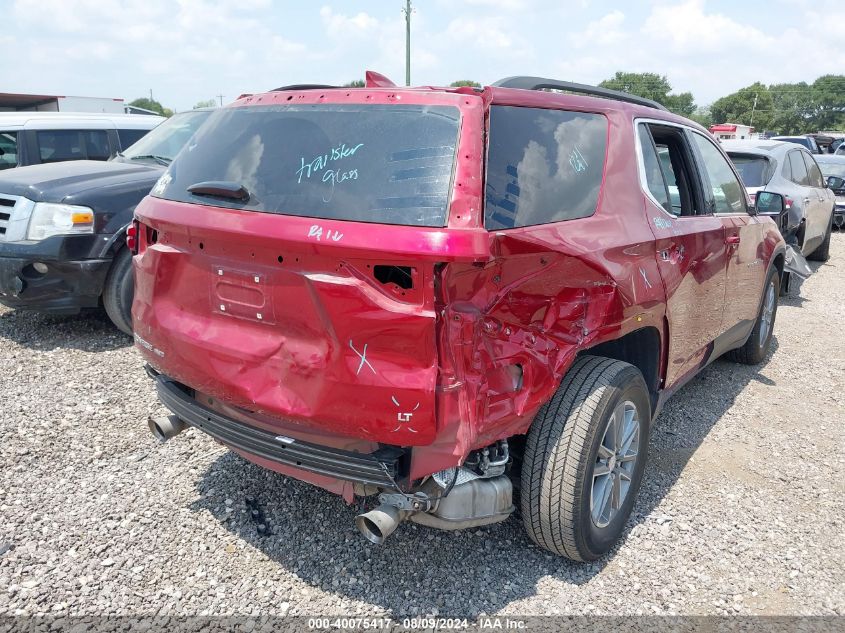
[{"left": 484, "top": 106, "right": 607, "bottom": 230}]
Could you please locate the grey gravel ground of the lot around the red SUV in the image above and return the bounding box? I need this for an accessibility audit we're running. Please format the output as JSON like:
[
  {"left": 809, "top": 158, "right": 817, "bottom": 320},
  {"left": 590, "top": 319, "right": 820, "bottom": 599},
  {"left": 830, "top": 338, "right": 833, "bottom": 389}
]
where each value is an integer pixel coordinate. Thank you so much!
[{"left": 0, "top": 233, "right": 845, "bottom": 616}]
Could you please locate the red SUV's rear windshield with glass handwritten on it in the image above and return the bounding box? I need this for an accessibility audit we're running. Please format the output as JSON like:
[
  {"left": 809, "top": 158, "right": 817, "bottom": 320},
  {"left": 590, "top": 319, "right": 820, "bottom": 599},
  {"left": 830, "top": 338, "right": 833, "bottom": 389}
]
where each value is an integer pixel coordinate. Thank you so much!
[{"left": 153, "top": 104, "right": 460, "bottom": 226}]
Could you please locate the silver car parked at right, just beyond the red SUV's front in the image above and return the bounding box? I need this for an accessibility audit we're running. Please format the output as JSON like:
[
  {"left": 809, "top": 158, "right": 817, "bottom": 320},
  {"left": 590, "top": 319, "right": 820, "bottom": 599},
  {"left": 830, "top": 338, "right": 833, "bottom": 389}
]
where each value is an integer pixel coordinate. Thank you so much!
[{"left": 722, "top": 140, "right": 836, "bottom": 261}]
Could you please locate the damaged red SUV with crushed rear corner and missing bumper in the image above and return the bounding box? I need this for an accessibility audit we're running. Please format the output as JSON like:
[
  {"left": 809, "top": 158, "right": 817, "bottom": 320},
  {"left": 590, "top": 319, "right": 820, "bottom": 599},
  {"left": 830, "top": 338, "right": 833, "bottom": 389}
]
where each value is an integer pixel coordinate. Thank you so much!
[{"left": 131, "top": 73, "right": 784, "bottom": 560}]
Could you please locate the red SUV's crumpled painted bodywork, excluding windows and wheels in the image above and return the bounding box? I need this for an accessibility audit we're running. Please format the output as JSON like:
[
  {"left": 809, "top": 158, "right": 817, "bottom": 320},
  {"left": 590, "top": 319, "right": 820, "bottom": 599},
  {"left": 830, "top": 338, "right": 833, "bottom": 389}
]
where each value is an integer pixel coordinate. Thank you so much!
[{"left": 133, "top": 80, "right": 782, "bottom": 499}]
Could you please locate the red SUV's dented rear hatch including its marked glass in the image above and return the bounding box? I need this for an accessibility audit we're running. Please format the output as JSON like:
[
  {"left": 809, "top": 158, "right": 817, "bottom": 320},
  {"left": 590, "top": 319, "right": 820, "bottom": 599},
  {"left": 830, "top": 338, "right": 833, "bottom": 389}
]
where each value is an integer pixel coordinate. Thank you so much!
[{"left": 133, "top": 91, "right": 488, "bottom": 445}]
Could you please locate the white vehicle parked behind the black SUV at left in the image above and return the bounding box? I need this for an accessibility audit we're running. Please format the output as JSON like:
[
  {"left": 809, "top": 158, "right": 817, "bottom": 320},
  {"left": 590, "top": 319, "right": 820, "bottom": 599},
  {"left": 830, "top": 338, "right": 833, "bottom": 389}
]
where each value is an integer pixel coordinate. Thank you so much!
[{"left": 0, "top": 112, "right": 164, "bottom": 169}]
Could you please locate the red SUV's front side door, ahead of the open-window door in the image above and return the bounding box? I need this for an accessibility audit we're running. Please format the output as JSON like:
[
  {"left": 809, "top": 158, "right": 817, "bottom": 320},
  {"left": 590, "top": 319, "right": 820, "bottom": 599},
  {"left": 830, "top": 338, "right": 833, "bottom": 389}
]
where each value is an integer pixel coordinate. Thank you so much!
[{"left": 690, "top": 132, "right": 767, "bottom": 337}]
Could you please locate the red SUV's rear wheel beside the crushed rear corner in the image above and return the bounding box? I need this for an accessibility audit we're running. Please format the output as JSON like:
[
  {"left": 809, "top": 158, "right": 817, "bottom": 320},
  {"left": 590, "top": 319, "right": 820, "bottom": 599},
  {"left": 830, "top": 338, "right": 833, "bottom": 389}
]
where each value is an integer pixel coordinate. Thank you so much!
[{"left": 520, "top": 356, "right": 651, "bottom": 561}]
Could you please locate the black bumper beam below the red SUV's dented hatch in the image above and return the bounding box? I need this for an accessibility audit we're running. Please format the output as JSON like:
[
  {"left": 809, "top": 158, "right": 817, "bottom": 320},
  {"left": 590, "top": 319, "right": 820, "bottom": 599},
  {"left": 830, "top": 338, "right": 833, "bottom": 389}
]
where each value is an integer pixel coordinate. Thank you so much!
[{"left": 156, "top": 375, "right": 404, "bottom": 488}]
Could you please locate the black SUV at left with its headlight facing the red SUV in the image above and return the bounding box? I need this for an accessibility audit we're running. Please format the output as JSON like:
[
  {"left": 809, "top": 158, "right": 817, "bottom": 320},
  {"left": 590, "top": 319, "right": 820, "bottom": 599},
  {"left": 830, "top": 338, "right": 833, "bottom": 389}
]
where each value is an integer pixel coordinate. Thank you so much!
[{"left": 0, "top": 110, "right": 210, "bottom": 333}]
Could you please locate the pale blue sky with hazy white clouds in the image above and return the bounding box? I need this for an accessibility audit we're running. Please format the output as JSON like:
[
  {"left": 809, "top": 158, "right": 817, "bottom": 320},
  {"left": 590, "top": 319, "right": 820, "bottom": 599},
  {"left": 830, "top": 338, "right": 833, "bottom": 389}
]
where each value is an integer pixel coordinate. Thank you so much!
[{"left": 0, "top": 0, "right": 845, "bottom": 111}]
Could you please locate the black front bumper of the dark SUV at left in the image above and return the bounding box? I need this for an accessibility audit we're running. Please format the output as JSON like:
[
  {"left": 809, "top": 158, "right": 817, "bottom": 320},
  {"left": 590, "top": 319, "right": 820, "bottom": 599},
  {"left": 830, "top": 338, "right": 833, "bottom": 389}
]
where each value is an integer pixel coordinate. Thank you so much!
[{"left": 0, "top": 244, "right": 111, "bottom": 314}]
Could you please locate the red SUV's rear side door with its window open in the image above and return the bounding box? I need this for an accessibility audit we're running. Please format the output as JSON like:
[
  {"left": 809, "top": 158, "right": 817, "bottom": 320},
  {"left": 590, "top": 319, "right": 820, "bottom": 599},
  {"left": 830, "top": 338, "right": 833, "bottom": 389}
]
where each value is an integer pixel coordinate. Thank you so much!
[{"left": 637, "top": 122, "right": 727, "bottom": 387}]
